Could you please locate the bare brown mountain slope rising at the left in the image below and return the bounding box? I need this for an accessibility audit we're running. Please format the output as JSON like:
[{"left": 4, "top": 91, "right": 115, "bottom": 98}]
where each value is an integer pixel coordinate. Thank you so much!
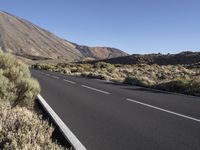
[{"left": 0, "top": 12, "right": 128, "bottom": 61}]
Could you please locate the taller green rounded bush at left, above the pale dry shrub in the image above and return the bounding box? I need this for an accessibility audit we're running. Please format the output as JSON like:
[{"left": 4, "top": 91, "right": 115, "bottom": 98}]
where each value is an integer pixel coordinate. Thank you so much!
[{"left": 0, "top": 52, "right": 40, "bottom": 108}]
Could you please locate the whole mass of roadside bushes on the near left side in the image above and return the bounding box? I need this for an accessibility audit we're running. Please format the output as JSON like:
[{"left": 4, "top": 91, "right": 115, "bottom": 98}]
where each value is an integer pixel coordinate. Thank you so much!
[{"left": 0, "top": 51, "right": 67, "bottom": 150}]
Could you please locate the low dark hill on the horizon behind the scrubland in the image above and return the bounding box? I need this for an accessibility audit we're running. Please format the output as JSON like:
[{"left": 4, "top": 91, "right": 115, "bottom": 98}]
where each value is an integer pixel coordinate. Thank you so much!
[{"left": 87, "top": 51, "right": 200, "bottom": 65}]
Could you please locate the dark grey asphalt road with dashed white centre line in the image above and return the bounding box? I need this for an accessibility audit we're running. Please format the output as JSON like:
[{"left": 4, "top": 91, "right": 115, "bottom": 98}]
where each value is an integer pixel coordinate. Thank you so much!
[{"left": 32, "top": 70, "right": 200, "bottom": 150}]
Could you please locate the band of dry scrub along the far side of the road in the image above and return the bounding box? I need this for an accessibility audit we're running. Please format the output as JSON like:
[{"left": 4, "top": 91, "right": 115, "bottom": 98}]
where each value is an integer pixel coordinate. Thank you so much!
[{"left": 33, "top": 62, "right": 200, "bottom": 96}]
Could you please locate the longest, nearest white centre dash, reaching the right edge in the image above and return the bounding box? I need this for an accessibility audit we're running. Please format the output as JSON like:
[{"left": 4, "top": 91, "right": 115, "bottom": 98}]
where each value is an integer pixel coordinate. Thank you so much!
[{"left": 126, "top": 98, "right": 200, "bottom": 123}]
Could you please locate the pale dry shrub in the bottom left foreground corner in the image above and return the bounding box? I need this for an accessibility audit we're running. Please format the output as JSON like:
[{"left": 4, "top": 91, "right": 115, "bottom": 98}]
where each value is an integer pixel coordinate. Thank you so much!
[{"left": 0, "top": 102, "right": 64, "bottom": 150}]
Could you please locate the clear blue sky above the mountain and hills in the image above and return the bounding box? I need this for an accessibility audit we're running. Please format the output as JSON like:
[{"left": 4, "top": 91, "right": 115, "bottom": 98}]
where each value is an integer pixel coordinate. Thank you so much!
[{"left": 0, "top": 0, "right": 200, "bottom": 54}]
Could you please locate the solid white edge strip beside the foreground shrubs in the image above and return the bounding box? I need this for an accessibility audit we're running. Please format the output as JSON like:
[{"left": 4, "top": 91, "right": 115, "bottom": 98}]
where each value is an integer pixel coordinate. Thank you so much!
[{"left": 37, "top": 94, "right": 86, "bottom": 150}]
